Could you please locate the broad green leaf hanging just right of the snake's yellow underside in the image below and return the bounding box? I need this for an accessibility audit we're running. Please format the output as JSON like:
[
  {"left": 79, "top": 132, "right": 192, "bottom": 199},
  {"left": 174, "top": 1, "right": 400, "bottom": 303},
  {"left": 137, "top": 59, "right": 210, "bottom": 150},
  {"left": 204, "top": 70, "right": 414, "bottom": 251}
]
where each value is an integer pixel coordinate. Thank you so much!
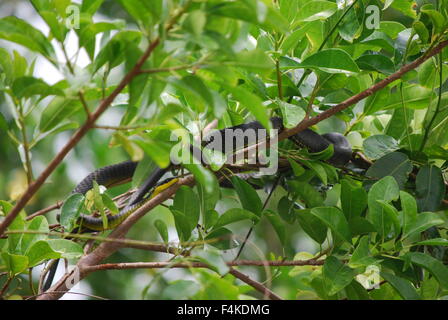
[{"left": 172, "top": 186, "right": 199, "bottom": 230}]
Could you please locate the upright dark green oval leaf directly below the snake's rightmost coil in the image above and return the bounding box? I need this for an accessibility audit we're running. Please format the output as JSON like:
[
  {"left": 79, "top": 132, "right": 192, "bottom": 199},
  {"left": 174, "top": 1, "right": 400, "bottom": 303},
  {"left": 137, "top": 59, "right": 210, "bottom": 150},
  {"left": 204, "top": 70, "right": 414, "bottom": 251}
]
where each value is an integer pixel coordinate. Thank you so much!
[{"left": 341, "top": 179, "right": 367, "bottom": 221}]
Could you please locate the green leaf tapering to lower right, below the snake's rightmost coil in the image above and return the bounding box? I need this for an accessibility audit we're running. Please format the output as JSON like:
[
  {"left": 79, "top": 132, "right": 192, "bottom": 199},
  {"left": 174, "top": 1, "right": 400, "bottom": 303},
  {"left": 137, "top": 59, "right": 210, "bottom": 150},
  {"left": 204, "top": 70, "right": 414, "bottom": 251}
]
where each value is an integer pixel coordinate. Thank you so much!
[{"left": 311, "top": 207, "right": 352, "bottom": 244}]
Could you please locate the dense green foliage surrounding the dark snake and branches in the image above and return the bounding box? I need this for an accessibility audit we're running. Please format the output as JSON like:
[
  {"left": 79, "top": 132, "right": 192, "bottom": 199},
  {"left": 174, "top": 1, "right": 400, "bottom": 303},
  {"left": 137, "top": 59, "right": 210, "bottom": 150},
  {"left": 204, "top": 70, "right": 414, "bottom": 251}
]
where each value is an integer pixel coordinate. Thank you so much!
[{"left": 0, "top": 0, "right": 448, "bottom": 299}]
